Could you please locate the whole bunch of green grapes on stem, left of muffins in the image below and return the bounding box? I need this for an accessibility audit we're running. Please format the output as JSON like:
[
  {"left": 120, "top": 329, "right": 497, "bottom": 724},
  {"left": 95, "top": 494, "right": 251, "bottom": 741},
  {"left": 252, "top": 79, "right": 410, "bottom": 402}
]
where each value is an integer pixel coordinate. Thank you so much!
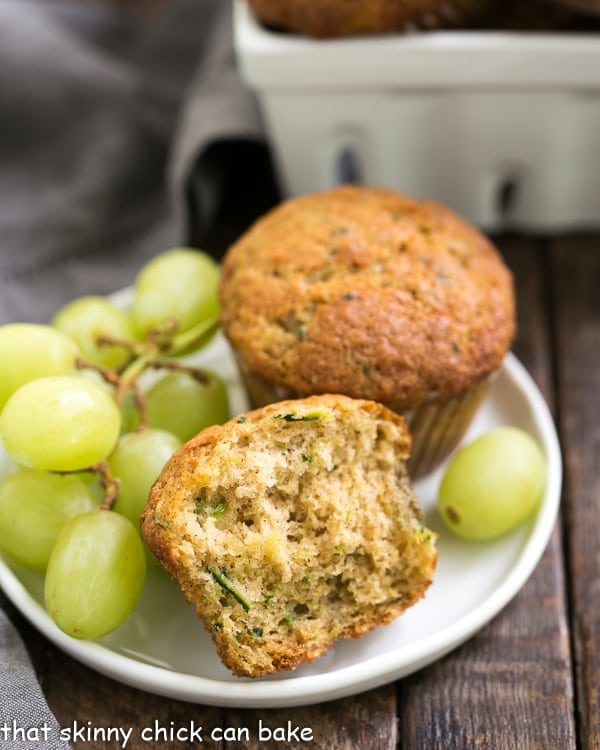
[{"left": 0, "top": 249, "right": 229, "bottom": 639}]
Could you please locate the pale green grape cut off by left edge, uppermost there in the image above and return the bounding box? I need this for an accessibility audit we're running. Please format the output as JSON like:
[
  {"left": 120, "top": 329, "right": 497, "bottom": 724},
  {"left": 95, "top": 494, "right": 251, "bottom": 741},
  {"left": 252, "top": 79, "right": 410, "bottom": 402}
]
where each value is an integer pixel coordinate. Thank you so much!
[{"left": 0, "top": 323, "right": 79, "bottom": 411}]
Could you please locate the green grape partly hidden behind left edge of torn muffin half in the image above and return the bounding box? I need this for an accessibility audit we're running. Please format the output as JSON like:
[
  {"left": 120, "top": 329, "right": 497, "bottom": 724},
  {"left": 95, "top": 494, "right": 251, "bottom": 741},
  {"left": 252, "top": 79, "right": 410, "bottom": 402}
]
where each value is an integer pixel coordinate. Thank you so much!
[{"left": 108, "top": 429, "right": 181, "bottom": 528}]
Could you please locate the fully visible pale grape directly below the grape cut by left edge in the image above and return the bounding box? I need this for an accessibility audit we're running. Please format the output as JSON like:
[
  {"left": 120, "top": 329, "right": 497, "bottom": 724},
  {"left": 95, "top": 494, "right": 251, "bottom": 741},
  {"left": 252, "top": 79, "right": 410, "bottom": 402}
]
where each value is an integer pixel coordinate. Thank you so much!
[{"left": 0, "top": 375, "right": 121, "bottom": 471}]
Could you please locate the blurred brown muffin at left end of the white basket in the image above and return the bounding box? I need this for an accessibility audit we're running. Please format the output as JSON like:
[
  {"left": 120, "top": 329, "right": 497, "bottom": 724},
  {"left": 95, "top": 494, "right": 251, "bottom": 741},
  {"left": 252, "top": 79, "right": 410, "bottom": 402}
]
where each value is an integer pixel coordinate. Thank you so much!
[{"left": 248, "top": 0, "right": 495, "bottom": 39}]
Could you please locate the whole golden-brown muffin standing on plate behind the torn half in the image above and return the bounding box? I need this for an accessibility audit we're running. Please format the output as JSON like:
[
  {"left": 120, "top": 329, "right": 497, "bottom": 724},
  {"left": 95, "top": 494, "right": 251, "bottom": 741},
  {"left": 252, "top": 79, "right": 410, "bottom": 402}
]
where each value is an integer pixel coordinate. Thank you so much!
[{"left": 220, "top": 186, "right": 515, "bottom": 478}]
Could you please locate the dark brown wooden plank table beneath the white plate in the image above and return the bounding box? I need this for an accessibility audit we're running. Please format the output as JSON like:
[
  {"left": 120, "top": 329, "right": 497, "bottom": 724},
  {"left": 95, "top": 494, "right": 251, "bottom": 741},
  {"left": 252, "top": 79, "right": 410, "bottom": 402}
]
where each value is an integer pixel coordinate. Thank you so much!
[{"left": 1, "top": 234, "right": 600, "bottom": 750}]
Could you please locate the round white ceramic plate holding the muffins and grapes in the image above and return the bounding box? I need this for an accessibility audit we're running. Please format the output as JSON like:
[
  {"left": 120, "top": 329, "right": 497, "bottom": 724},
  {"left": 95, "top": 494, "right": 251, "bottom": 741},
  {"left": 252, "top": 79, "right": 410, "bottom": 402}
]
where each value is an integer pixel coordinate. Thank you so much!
[{"left": 0, "top": 337, "right": 561, "bottom": 708}]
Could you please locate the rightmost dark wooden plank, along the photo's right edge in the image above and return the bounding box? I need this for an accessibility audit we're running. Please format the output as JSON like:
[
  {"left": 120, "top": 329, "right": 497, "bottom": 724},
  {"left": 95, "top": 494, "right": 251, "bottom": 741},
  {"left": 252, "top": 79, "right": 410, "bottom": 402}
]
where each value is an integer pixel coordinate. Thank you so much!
[{"left": 551, "top": 237, "right": 600, "bottom": 750}]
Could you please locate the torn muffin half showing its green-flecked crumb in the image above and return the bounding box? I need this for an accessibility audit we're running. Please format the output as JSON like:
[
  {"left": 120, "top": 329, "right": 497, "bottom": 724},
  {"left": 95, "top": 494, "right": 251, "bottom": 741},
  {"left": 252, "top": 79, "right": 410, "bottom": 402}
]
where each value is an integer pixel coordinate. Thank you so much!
[{"left": 141, "top": 395, "right": 437, "bottom": 677}]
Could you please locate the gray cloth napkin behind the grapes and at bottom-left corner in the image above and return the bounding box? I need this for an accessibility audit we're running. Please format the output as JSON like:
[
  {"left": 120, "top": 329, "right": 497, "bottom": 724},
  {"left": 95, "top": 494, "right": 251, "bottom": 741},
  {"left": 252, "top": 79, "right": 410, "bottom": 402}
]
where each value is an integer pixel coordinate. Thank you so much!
[{"left": 0, "top": 0, "right": 262, "bottom": 750}]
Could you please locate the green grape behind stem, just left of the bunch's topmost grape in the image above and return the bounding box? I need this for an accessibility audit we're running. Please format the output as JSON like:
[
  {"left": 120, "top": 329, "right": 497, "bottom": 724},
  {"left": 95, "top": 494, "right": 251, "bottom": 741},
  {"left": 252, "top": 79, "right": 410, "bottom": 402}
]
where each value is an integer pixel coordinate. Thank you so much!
[{"left": 52, "top": 296, "right": 135, "bottom": 368}]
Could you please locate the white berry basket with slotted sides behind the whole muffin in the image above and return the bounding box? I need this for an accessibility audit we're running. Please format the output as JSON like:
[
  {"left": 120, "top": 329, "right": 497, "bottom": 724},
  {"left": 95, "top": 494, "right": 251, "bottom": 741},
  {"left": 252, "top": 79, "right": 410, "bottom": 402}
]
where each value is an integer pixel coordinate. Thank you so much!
[{"left": 234, "top": 0, "right": 600, "bottom": 231}]
